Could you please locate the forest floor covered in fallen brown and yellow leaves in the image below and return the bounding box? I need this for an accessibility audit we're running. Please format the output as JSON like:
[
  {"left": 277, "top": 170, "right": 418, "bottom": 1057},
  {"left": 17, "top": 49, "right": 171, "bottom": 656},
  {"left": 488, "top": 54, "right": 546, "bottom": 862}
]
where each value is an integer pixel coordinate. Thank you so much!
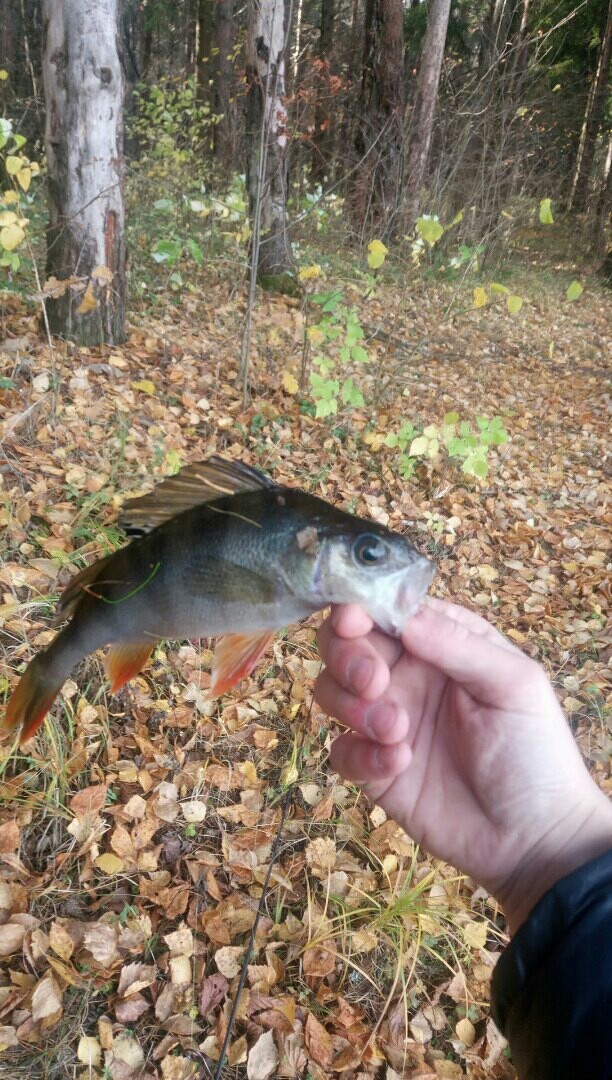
[{"left": 0, "top": 261, "right": 612, "bottom": 1080}]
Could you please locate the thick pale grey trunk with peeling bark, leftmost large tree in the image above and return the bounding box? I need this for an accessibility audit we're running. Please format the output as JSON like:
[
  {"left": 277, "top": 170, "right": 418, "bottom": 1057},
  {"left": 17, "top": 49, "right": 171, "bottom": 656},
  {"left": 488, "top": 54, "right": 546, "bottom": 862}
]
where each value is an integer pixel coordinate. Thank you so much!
[{"left": 42, "top": 0, "right": 125, "bottom": 346}]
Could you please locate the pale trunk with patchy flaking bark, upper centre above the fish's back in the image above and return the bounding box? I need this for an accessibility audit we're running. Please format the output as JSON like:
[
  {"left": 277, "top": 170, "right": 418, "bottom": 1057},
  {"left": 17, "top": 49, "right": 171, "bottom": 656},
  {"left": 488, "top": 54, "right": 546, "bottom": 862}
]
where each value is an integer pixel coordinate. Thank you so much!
[{"left": 246, "top": 0, "right": 294, "bottom": 285}]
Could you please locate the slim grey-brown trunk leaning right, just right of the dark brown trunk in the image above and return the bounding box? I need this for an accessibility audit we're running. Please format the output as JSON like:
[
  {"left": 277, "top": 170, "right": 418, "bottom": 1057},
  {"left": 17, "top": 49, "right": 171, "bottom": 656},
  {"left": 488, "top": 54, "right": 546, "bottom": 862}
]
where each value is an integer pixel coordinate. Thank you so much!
[{"left": 406, "top": 0, "right": 450, "bottom": 225}]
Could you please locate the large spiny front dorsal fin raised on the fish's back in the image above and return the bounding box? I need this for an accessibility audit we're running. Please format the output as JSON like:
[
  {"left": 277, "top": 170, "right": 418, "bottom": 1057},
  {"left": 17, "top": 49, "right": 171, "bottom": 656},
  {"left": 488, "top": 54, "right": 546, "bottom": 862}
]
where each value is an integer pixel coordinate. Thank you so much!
[{"left": 119, "top": 455, "right": 277, "bottom": 535}]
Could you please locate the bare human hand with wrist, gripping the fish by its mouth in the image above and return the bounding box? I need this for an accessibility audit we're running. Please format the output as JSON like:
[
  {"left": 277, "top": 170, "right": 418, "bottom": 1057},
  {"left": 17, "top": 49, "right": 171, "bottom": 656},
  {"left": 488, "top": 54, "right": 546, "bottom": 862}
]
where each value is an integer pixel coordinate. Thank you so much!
[{"left": 315, "top": 598, "right": 612, "bottom": 932}]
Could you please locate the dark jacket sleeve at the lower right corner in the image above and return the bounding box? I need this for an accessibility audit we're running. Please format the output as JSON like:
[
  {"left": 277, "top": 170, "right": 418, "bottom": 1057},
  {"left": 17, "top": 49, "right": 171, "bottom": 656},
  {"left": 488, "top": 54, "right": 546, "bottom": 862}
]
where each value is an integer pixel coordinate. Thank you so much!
[{"left": 491, "top": 851, "right": 612, "bottom": 1080}]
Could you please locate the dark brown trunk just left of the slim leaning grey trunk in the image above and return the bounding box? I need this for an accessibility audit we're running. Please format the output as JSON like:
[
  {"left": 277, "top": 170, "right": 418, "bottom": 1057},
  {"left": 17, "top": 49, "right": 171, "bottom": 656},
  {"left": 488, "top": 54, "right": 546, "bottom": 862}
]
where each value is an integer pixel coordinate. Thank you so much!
[{"left": 351, "top": 0, "right": 404, "bottom": 237}]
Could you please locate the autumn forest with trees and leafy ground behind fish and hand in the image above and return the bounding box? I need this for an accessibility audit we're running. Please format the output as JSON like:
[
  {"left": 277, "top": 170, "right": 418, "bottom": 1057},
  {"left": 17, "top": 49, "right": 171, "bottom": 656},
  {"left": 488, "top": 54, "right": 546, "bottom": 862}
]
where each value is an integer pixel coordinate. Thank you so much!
[{"left": 0, "top": 0, "right": 612, "bottom": 1080}]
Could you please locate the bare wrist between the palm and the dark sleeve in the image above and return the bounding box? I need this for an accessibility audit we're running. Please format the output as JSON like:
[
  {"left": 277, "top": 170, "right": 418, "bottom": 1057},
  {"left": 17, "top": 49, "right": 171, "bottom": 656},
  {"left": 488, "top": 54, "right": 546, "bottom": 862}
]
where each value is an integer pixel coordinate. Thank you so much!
[{"left": 497, "top": 791, "right": 612, "bottom": 934}]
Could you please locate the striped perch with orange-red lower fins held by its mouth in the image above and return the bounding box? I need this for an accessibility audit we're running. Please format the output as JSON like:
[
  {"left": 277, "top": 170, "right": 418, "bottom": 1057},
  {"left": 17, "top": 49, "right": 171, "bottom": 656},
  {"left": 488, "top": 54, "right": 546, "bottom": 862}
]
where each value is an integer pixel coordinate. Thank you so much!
[{"left": 0, "top": 456, "right": 435, "bottom": 744}]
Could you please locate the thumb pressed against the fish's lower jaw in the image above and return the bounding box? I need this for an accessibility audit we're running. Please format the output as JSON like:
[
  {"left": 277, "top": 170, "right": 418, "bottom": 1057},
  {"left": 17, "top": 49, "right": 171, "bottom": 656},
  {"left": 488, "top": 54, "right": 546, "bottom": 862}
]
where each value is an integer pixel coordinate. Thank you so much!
[{"left": 402, "top": 604, "right": 540, "bottom": 706}]
